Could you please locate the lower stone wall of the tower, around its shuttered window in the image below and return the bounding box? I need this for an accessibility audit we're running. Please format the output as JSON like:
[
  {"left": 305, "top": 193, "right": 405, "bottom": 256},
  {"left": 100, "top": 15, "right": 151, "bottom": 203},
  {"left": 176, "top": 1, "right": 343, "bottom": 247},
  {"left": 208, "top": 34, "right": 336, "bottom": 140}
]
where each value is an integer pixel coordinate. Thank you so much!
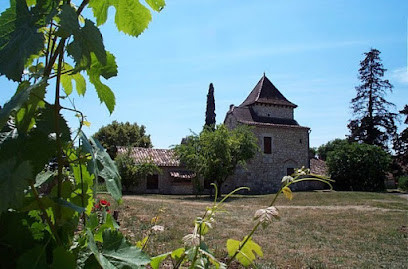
[{"left": 223, "top": 114, "right": 312, "bottom": 193}]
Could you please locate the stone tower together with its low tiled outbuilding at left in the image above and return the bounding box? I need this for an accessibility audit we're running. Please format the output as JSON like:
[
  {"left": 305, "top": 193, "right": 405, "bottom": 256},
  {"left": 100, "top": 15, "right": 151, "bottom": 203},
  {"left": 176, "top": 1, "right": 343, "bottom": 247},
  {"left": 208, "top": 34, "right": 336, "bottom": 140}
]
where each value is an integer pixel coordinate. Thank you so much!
[{"left": 124, "top": 74, "right": 321, "bottom": 194}]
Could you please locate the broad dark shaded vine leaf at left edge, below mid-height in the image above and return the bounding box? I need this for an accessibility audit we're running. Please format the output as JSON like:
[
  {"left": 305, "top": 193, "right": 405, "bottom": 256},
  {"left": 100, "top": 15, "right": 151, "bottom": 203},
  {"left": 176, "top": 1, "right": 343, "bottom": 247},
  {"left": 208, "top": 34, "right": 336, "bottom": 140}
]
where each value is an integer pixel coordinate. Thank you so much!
[{"left": 0, "top": 157, "right": 32, "bottom": 213}]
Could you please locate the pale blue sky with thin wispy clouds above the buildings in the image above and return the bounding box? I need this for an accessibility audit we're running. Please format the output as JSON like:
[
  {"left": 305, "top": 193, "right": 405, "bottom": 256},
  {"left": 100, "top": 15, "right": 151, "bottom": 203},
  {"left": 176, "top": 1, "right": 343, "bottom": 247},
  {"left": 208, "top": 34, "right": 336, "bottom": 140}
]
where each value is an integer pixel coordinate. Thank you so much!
[{"left": 0, "top": 0, "right": 408, "bottom": 148}]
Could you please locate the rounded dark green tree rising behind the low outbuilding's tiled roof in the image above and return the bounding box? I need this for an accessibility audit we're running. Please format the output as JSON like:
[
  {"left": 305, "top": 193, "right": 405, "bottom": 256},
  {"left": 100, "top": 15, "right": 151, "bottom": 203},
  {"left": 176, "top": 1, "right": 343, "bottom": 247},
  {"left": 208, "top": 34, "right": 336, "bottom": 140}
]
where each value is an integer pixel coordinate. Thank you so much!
[{"left": 93, "top": 121, "right": 153, "bottom": 159}]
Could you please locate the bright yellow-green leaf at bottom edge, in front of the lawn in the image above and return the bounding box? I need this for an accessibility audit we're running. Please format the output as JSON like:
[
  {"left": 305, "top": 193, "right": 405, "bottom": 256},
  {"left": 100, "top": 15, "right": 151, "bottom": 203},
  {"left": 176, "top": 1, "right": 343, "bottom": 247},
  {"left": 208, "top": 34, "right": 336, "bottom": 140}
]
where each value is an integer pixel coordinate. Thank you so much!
[{"left": 227, "top": 238, "right": 263, "bottom": 266}]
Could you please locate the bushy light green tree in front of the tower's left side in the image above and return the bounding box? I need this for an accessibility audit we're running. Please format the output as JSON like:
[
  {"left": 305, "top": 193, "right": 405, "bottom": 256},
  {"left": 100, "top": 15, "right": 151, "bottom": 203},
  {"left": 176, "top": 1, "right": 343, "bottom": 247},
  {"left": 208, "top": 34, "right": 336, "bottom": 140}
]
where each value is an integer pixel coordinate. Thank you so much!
[{"left": 175, "top": 124, "right": 259, "bottom": 193}]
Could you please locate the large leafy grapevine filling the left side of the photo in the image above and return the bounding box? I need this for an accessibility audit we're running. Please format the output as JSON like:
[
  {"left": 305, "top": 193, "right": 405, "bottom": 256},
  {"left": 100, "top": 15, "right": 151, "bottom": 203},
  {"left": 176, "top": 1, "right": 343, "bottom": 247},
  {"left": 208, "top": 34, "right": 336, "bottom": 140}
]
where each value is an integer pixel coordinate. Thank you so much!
[{"left": 0, "top": 0, "right": 164, "bottom": 268}]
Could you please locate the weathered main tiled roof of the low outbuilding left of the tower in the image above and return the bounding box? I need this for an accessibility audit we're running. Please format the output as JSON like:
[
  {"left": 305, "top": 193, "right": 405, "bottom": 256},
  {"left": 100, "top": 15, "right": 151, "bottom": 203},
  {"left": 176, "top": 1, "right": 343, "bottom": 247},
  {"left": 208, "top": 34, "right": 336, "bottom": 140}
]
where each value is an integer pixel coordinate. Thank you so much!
[{"left": 118, "top": 147, "right": 180, "bottom": 166}]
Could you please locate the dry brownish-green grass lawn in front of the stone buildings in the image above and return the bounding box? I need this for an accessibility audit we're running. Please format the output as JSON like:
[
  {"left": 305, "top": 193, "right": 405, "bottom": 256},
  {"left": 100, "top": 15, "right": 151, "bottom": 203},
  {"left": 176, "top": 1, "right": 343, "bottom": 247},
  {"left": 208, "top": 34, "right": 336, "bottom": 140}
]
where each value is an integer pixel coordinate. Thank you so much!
[{"left": 109, "top": 192, "right": 408, "bottom": 268}]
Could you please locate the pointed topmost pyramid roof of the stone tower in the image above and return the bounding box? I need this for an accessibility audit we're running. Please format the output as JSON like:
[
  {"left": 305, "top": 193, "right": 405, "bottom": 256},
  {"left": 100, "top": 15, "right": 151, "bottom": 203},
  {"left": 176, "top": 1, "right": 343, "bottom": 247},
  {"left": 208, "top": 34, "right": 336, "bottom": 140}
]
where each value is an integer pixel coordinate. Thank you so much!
[{"left": 240, "top": 73, "right": 297, "bottom": 108}]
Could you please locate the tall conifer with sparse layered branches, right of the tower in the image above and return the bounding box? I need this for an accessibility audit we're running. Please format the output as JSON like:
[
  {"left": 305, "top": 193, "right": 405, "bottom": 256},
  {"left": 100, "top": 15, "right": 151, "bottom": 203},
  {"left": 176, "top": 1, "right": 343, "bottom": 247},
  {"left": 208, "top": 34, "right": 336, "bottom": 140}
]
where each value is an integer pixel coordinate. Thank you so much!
[{"left": 347, "top": 49, "right": 397, "bottom": 149}]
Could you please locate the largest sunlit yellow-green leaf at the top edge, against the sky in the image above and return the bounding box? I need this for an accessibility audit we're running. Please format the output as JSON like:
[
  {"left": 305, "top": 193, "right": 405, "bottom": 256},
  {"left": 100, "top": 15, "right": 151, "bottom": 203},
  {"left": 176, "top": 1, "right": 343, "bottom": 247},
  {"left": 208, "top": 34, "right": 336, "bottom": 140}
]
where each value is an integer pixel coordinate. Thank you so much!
[{"left": 115, "top": 0, "right": 152, "bottom": 36}]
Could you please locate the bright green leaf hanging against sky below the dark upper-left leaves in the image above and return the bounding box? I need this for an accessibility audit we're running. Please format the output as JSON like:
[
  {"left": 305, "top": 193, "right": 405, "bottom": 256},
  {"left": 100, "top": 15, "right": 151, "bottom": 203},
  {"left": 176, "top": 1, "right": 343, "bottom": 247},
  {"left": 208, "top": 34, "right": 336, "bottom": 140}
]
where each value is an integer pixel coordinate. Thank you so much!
[{"left": 87, "top": 52, "right": 117, "bottom": 114}]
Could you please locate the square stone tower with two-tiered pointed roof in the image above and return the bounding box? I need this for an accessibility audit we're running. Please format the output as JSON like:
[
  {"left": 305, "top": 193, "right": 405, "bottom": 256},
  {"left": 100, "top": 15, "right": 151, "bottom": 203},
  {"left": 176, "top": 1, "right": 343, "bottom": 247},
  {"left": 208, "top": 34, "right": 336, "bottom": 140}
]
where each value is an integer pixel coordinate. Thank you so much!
[{"left": 224, "top": 74, "right": 310, "bottom": 193}]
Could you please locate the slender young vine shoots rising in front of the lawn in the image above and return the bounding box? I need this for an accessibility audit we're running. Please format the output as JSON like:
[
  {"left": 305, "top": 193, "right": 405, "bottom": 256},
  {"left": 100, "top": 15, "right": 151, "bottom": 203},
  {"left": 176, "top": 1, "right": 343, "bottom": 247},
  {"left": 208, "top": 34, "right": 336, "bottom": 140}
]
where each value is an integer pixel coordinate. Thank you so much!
[{"left": 150, "top": 167, "right": 332, "bottom": 269}]
